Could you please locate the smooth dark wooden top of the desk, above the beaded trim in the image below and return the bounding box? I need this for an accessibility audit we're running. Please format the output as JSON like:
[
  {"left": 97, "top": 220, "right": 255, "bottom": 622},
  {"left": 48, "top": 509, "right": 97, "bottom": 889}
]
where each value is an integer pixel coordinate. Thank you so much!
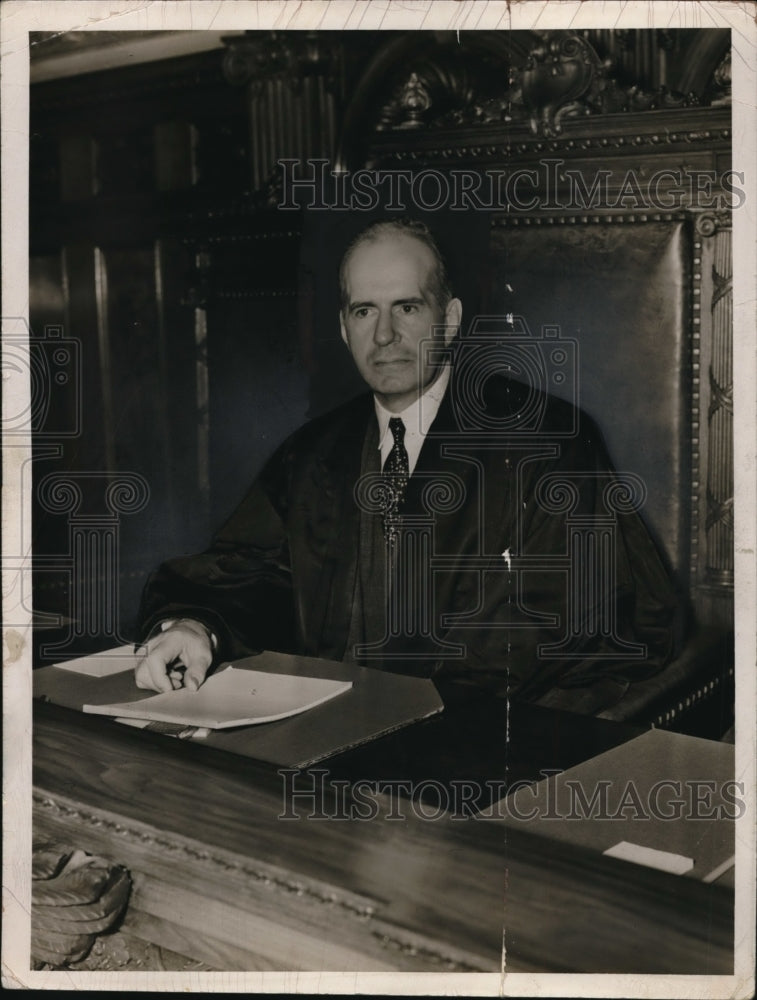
[{"left": 34, "top": 692, "right": 732, "bottom": 973}]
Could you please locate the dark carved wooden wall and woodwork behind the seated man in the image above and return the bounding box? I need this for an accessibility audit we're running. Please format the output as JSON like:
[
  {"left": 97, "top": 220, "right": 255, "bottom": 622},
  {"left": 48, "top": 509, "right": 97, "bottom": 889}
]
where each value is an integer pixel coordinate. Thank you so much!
[{"left": 30, "top": 30, "right": 733, "bottom": 656}]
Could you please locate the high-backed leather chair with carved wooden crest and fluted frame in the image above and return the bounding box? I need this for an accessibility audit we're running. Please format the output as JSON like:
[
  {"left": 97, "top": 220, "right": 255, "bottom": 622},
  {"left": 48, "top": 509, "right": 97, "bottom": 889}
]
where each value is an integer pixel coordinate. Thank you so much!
[{"left": 340, "top": 31, "right": 734, "bottom": 736}]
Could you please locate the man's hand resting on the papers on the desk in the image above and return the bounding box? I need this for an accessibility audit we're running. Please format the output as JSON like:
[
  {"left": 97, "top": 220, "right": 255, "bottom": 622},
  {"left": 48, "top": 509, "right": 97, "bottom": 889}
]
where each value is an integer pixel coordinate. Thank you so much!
[{"left": 134, "top": 618, "right": 213, "bottom": 692}]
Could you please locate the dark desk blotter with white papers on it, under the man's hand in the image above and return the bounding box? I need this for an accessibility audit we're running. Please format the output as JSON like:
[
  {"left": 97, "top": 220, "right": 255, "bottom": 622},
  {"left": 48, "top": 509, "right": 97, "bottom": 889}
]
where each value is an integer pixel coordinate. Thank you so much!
[{"left": 33, "top": 645, "right": 443, "bottom": 767}]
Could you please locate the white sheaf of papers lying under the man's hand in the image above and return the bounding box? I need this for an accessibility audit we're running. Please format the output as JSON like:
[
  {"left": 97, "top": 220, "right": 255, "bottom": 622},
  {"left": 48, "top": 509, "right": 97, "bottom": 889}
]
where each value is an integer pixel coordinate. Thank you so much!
[{"left": 82, "top": 665, "right": 352, "bottom": 729}]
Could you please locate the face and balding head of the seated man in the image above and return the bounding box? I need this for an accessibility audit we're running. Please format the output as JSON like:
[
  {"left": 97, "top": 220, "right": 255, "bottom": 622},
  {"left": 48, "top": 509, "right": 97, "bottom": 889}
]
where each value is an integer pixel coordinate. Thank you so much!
[{"left": 340, "top": 233, "right": 461, "bottom": 413}]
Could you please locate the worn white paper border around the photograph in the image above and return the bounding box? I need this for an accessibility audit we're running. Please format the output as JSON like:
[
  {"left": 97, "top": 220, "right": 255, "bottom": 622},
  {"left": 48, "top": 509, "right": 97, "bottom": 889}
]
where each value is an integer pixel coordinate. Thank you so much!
[{"left": 0, "top": 0, "right": 757, "bottom": 998}]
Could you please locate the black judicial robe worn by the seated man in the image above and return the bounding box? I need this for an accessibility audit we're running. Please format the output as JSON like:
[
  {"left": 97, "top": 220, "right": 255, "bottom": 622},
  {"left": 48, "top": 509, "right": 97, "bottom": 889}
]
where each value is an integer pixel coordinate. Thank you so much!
[{"left": 140, "top": 376, "right": 678, "bottom": 699}]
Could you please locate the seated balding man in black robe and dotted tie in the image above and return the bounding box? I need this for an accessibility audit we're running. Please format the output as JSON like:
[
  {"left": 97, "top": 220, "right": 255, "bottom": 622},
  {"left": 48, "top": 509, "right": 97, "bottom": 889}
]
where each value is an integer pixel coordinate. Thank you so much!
[{"left": 136, "top": 220, "right": 676, "bottom": 699}]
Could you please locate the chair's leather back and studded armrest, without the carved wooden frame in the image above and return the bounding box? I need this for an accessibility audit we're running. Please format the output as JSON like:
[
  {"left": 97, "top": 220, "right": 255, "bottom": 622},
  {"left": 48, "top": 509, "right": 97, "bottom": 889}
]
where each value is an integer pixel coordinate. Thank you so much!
[{"left": 486, "top": 219, "right": 731, "bottom": 735}]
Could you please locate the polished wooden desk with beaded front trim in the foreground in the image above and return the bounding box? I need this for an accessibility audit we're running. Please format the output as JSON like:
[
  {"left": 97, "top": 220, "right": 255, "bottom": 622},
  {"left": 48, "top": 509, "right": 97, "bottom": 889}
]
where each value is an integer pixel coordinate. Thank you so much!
[{"left": 34, "top": 705, "right": 733, "bottom": 974}]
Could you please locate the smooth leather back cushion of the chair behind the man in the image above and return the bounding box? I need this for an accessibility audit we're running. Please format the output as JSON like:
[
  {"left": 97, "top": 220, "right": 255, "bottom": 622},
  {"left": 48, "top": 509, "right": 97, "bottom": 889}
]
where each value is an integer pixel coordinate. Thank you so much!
[{"left": 484, "top": 219, "right": 692, "bottom": 583}]
